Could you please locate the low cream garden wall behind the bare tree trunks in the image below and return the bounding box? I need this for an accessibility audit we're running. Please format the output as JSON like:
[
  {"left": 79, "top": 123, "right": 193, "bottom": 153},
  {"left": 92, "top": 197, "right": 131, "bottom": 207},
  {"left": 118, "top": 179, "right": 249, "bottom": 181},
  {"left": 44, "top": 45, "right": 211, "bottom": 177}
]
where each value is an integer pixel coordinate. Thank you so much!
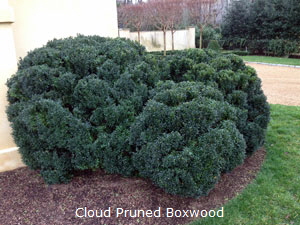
[{"left": 119, "top": 27, "right": 195, "bottom": 52}]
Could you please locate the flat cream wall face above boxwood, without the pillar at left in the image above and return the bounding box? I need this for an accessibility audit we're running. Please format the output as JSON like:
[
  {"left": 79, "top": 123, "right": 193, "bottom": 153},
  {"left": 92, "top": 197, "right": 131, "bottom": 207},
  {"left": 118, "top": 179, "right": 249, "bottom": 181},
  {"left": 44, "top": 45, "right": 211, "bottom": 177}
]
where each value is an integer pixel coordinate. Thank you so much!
[{"left": 9, "top": 0, "right": 118, "bottom": 58}]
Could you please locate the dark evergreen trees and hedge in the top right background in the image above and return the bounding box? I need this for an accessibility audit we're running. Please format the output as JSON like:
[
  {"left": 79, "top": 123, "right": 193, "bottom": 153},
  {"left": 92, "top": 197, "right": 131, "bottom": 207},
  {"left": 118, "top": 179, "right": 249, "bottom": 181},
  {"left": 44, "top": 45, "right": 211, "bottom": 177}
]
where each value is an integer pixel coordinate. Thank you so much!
[{"left": 222, "top": 0, "right": 300, "bottom": 55}]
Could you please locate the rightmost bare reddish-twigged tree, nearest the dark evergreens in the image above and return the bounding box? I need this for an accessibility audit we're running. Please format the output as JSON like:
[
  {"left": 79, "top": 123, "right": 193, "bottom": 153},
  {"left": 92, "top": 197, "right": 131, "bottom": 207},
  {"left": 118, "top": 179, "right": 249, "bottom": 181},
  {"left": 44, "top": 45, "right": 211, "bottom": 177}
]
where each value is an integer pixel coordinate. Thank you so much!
[{"left": 185, "top": 0, "right": 221, "bottom": 48}]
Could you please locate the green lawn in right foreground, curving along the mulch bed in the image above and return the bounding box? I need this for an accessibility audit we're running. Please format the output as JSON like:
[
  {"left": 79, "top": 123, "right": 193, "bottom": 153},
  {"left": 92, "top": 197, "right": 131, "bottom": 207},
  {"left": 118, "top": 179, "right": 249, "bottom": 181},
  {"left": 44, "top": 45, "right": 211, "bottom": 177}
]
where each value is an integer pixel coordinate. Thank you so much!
[{"left": 192, "top": 105, "right": 300, "bottom": 225}]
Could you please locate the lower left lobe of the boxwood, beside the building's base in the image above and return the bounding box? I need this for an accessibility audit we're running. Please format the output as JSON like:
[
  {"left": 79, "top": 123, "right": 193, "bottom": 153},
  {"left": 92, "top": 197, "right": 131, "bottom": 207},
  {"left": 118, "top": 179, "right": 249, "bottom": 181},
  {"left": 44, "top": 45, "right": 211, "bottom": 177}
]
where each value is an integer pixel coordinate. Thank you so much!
[{"left": 8, "top": 99, "right": 95, "bottom": 184}]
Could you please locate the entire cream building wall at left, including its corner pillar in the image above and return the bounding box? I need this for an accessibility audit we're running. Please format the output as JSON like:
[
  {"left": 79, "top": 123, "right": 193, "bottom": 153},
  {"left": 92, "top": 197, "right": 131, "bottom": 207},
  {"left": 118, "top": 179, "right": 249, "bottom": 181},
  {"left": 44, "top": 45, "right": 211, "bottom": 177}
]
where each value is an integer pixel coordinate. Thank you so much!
[{"left": 0, "top": 0, "right": 118, "bottom": 172}]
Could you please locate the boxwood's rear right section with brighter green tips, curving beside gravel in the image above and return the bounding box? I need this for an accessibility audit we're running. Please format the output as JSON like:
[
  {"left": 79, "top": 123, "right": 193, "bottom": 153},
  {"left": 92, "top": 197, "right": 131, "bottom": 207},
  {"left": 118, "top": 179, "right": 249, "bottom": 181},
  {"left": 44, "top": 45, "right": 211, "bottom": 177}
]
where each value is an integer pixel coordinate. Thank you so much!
[{"left": 159, "top": 49, "right": 269, "bottom": 154}]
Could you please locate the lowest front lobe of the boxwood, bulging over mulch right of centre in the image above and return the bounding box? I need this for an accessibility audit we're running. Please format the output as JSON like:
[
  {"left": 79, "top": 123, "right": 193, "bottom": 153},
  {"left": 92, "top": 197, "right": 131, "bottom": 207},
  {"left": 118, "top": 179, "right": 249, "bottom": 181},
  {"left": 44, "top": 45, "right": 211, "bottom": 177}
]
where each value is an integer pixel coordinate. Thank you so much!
[{"left": 135, "top": 133, "right": 220, "bottom": 197}]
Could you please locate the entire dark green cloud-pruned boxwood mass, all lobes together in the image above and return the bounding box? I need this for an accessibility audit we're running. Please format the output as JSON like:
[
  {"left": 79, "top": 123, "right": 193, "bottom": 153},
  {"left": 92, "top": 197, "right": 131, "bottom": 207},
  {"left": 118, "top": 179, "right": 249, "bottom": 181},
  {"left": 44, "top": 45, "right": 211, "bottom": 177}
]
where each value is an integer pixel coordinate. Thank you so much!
[{"left": 7, "top": 36, "right": 269, "bottom": 197}]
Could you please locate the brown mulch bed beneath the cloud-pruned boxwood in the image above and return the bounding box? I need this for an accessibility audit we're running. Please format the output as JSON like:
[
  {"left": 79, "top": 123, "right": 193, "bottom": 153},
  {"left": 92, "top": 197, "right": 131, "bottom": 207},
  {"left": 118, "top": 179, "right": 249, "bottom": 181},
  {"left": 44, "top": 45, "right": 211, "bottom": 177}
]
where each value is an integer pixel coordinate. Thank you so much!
[{"left": 0, "top": 148, "right": 266, "bottom": 225}]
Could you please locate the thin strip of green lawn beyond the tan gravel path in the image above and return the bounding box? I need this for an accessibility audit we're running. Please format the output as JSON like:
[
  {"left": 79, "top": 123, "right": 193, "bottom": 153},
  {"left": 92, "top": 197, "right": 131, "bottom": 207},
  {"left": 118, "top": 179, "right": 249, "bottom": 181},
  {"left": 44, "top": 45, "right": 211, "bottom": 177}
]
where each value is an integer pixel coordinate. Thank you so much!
[{"left": 241, "top": 55, "right": 300, "bottom": 66}]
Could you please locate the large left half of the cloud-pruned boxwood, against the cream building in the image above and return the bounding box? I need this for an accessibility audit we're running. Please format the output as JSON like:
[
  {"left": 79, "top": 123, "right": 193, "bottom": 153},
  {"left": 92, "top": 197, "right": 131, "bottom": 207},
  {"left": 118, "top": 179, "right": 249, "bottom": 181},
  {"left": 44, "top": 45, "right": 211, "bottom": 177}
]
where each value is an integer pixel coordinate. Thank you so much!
[{"left": 7, "top": 36, "right": 158, "bottom": 183}]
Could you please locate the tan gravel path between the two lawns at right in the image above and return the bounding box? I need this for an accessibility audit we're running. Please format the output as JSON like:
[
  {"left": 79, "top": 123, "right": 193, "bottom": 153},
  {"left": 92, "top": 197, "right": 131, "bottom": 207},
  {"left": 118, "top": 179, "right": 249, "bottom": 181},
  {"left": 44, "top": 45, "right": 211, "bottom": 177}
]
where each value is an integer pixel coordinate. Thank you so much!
[{"left": 246, "top": 62, "right": 300, "bottom": 106}]
